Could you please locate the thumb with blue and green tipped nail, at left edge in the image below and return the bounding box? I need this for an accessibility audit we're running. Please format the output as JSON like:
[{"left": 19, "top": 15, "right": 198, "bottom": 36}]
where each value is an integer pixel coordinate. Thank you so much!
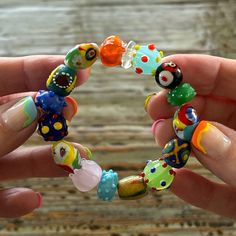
[{"left": 0, "top": 96, "right": 38, "bottom": 157}]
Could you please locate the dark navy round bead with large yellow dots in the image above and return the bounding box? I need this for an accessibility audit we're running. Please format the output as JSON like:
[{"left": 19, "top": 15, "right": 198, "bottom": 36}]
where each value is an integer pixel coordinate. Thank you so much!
[{"left": 38, "top": 113, "right": 68, "bottom": 141}]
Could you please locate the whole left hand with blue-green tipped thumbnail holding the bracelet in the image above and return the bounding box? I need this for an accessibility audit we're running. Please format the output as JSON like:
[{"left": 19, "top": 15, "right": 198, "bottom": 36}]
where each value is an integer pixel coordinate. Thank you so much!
[{"left": 0, "top": 56, "right": 89, "bottom": 217}]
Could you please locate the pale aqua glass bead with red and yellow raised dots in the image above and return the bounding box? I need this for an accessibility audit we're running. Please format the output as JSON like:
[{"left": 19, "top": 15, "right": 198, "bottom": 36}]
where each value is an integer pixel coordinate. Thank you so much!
[{"left": 131, "top": 44, "right": 163, "bottom": 75}]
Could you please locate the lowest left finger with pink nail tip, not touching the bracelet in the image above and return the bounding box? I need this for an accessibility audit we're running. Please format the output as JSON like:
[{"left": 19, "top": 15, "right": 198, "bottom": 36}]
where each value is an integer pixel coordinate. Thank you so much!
[{"left": 0, "top": 188, "right": 42, "bottom": 218}]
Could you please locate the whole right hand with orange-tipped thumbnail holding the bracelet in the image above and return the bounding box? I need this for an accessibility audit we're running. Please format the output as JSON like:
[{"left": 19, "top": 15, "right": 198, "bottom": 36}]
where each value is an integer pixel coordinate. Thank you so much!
[{"left": 146, "top": 55, "right": 236, "bottom": 218}]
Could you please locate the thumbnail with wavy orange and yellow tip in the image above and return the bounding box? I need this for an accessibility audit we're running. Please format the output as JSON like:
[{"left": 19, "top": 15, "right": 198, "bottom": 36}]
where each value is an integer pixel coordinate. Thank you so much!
[{"left": 191, "top": 121, "right": 231, "bottom": 159}]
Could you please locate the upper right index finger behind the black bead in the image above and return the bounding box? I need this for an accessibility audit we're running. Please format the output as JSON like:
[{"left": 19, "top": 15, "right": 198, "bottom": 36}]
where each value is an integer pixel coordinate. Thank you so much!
[{"left": 163, "top": 54, "right": 236, "bottom": 101}]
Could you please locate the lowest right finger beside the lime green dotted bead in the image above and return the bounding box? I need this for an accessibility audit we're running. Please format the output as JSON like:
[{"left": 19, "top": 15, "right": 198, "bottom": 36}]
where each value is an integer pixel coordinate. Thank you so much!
[{"left": 170, "top": 169, "right": 236, "bottom": 218}]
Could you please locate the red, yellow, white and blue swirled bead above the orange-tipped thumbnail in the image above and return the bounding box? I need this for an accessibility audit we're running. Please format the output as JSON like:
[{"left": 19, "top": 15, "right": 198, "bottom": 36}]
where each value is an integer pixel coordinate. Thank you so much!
[{"left": 173, "top": 104, "right": 199, "bottom": 141}]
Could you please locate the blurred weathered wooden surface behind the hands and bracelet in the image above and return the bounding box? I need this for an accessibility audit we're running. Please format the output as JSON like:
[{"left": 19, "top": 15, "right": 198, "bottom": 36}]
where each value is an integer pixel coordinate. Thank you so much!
[{"left": 0, "top": 0, "right": 236, "bottom": 236}]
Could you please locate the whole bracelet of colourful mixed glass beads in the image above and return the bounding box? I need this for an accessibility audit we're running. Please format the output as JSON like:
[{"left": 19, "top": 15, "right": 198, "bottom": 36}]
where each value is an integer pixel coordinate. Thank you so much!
[{"left": 35, "top": 36, "right": 199, "bottom": 201}]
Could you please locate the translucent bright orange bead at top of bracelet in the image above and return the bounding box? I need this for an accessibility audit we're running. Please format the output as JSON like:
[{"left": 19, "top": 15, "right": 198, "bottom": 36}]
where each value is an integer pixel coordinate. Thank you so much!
[{"left": 100, "top": 35, "right": 125, "bottom": 67}]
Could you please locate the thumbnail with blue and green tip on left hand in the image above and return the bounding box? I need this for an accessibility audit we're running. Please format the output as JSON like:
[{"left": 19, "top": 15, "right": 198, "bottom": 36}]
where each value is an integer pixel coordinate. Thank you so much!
[{"left": 1, "top": 96, "right": 37, "bottom": 131}]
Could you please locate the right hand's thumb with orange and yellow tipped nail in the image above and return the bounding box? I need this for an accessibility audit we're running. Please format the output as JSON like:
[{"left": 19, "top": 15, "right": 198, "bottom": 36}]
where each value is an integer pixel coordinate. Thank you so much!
[{"left": 191, "top": 121, "right": 236, "bottom": 187}]
